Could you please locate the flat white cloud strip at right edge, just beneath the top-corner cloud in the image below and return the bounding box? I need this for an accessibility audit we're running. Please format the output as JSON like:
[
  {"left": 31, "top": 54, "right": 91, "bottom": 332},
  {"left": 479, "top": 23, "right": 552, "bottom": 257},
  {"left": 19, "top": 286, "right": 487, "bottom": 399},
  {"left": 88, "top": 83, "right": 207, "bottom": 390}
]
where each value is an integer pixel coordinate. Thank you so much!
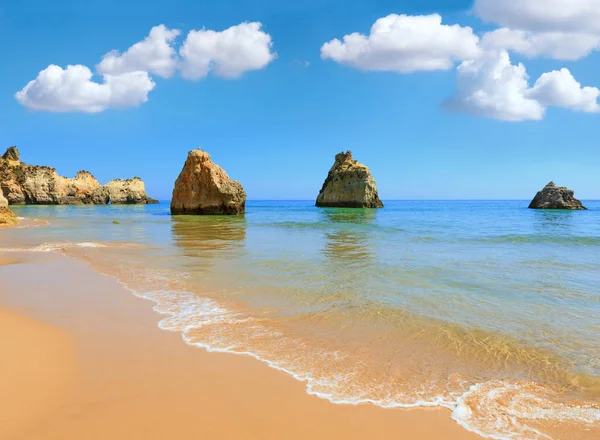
[{"left": 481, "top": 28, "right": 600, "bottom": 61}]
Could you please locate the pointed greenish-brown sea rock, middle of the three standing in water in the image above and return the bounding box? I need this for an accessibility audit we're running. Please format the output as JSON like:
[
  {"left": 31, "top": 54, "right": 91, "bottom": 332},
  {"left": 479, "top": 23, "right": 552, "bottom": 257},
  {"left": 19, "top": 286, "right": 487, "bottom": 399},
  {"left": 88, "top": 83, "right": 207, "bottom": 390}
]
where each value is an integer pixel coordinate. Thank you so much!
[{"left": 317, "top": 151, "right": 383, "bottom": 208}]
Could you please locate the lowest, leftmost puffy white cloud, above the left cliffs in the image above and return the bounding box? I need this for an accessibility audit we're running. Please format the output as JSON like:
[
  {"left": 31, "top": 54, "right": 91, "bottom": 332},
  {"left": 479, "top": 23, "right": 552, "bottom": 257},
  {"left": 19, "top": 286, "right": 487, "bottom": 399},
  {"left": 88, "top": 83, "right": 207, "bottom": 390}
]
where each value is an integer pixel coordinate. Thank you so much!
[{"left": 15, "top": 65, "right": 155, "bottom": 113}]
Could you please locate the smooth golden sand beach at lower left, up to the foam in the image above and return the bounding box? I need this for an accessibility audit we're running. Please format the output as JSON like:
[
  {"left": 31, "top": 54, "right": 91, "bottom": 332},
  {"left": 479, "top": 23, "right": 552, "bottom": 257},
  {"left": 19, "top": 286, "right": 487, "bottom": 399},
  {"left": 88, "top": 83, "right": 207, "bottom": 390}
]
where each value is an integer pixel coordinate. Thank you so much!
[{"left": 0, "top": 253, "right": 479, "bottom": 440}]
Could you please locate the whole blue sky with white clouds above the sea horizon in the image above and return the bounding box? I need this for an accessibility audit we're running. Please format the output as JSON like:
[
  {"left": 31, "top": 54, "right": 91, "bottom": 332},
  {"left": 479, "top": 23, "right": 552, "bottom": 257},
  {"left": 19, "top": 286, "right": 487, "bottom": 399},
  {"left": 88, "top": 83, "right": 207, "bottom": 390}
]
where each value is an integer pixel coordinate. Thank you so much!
[{"left": 0, "top": 0, "right": 600, "bottom": 201}]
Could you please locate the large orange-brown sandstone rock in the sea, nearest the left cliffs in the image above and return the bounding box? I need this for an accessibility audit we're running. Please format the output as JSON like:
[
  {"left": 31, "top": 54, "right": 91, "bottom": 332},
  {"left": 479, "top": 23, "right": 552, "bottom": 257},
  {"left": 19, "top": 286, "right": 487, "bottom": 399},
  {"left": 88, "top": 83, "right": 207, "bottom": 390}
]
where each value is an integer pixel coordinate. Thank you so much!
[{"left": 171, "top": 149, "right": 246, "bottom": 215}]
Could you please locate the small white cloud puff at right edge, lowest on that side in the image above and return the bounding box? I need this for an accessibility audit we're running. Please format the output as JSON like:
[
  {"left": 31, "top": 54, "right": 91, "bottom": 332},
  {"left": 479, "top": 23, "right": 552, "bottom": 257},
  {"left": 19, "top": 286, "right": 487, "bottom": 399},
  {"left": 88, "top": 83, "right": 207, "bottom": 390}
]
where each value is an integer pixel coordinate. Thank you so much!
[{"left": 529, "top": 69, "right": 600, "bottom": 113}]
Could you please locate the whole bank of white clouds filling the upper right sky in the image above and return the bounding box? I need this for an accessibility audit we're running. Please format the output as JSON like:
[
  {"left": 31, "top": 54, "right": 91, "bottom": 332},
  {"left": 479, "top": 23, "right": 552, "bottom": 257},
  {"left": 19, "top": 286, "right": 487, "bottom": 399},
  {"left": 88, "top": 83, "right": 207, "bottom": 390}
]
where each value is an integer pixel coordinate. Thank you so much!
[{"left": 321, "top": 4, "right": 600, "bottom": 121}]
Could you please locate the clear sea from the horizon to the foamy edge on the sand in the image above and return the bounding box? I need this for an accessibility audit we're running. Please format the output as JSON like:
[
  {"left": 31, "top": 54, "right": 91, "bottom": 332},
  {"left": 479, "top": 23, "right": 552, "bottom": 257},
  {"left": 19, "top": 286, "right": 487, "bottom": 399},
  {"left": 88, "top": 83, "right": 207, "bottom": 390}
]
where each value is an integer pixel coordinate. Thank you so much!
[{"left": 0, "top": 201, "right": 600, "bottom": 439}]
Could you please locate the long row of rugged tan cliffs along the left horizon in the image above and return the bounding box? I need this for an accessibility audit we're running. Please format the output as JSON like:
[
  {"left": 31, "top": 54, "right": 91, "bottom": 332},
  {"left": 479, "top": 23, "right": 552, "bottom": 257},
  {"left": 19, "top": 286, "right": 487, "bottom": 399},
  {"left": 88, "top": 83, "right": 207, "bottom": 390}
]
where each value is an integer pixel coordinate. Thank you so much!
[{"left": 0, "top": 147, "right": 156, "bottom": 205}]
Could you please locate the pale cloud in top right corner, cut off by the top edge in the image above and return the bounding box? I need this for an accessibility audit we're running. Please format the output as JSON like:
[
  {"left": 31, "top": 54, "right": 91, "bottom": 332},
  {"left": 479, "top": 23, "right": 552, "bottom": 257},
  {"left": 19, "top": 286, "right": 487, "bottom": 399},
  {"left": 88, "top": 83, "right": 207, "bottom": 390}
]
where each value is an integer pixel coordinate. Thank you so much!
[{"left": 474, "top": 0, "right": 600, "bottom": 33}]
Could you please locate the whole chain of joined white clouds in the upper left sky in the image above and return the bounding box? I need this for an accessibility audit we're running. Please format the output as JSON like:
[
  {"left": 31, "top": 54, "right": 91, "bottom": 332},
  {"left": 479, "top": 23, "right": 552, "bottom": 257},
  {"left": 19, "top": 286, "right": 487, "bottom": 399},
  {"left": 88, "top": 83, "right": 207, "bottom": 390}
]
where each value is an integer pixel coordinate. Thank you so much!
[{"left": 15, "top": 22, "right": 276, "bottom": 113}]
